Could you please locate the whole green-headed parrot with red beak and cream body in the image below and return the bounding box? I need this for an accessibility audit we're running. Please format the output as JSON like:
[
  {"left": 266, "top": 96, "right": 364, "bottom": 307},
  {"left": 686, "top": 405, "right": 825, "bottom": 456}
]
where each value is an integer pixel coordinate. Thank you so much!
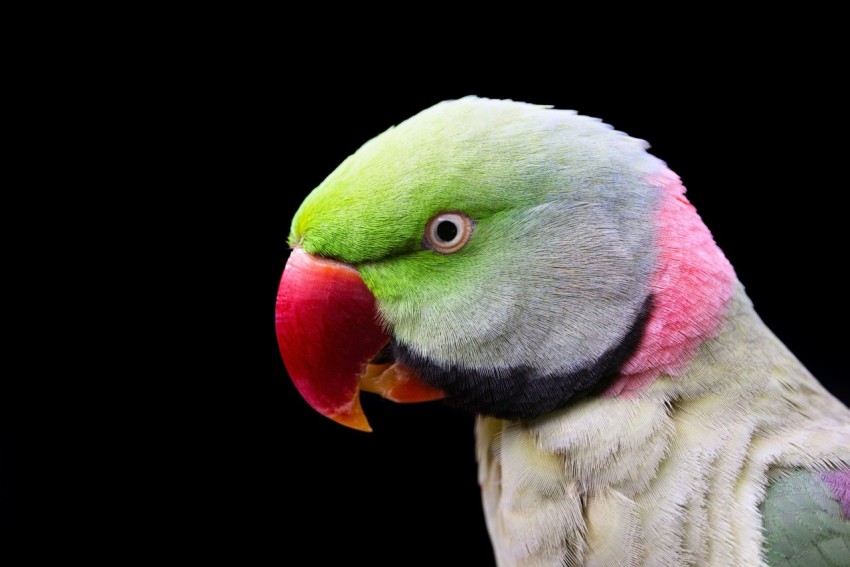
[{"left": 275, "top": 97, "right": 850, "bottom": 567}]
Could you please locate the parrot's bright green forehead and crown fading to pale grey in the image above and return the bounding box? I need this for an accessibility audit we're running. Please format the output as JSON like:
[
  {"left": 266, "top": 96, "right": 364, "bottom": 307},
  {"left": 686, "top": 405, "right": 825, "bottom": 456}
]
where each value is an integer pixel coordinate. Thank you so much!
[{"left": 289, "top": 97, "right": 658, "bottom": 264}]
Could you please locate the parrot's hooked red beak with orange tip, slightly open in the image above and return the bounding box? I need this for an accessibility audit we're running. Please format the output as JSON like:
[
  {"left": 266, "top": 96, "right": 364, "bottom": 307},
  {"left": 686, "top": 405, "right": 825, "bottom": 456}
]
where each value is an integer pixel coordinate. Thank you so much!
[{"left": 275, "top": 248, "right": 444, "bottom": 431}]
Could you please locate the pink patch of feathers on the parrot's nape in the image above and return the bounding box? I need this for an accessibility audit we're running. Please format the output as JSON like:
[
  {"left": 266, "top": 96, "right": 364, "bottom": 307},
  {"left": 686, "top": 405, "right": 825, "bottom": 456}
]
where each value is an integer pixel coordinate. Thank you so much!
[{"left": 604, "top": 170, "right": 735, "bottom": 397}]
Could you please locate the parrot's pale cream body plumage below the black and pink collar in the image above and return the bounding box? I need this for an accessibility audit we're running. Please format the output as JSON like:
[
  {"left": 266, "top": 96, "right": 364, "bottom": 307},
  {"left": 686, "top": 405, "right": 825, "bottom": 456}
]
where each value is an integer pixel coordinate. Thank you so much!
[{"left": 478, "top": 286, "right": 850, "bottom": 566}]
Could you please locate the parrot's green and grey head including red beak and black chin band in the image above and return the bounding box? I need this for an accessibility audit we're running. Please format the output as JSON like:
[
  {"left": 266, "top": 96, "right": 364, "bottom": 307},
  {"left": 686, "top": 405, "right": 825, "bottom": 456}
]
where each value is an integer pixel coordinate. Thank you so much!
[{"left": 276, "top": 97, "right": 731, "bottom": 430}]
